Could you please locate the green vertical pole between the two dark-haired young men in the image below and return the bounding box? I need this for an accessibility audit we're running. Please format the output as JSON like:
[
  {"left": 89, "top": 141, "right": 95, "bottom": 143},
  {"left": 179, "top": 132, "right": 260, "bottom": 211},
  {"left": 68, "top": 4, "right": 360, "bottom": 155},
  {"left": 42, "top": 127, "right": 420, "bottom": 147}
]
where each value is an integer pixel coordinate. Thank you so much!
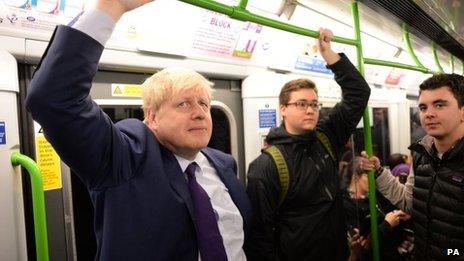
[{"left": 351, "top": 1, "right": 380, "bottom": 261}]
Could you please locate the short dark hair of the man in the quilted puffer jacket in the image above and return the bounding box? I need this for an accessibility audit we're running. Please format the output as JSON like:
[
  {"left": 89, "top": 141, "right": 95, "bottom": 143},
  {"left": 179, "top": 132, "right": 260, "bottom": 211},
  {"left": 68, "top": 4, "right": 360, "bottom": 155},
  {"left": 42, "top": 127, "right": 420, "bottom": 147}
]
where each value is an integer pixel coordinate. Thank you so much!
[{"left": 419, "top": 73, "right": 464, "bottom": 107}]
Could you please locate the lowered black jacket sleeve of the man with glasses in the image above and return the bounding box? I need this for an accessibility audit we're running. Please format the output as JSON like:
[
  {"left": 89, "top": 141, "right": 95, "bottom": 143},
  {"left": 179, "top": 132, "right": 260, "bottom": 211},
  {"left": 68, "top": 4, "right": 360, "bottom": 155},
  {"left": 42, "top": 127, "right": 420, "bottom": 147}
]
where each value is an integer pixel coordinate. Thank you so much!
[{"left": 245, "top": 154, "right": 280, "bottom": 261}]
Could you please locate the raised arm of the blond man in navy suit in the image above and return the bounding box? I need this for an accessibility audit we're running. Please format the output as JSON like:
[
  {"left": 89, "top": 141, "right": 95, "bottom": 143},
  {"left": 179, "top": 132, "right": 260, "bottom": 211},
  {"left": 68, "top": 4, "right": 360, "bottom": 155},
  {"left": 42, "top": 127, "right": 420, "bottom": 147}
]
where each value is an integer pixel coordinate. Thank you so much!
[{"left": 26, "top": 0, "right": 152, "bottom": 187}]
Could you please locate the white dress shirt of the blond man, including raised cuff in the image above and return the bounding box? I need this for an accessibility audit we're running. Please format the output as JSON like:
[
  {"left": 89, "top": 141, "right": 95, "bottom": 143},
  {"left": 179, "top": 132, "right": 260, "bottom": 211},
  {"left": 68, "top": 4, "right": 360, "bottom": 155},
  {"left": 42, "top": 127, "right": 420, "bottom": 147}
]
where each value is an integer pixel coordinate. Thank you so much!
[{"left": 70, "top": 10, "right": 246, "bottom": 261}]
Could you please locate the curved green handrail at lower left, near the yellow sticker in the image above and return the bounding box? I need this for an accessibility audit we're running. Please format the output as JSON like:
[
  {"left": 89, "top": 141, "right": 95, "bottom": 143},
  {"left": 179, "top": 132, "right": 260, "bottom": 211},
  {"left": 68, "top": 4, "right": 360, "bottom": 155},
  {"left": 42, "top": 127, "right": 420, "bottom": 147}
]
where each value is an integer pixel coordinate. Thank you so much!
[{"left": 11, "top": 152, "right": 49, "bottom": 261}]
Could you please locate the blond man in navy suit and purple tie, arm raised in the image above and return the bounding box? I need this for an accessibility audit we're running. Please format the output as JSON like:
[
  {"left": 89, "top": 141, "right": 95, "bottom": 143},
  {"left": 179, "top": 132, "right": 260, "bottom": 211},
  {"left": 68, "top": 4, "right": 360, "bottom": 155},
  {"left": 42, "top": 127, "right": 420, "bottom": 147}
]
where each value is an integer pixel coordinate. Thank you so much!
[{"left": 26, "top": 0, "right": 251, "bottom": 261}]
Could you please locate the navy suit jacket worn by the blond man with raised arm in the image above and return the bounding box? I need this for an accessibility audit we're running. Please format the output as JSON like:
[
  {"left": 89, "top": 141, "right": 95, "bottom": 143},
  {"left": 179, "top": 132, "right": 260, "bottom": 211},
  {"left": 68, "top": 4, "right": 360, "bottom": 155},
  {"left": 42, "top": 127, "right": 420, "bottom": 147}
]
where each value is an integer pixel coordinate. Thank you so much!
[{"left": 26, "top": 26, "right": 251, "bottom": 260}]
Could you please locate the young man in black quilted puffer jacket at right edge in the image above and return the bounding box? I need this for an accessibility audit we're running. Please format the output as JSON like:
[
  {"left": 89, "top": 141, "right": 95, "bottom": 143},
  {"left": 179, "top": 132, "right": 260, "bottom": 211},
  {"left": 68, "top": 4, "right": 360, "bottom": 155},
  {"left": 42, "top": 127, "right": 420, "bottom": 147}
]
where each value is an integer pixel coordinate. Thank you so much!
[{"left": 365, "top": 74, "right": 464, "bottom": 260}]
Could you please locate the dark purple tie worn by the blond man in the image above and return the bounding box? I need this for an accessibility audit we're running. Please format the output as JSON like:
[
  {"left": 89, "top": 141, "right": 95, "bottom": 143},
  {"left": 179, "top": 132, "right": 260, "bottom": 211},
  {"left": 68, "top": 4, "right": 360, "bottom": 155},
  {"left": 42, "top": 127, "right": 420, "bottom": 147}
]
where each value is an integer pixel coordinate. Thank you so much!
[{"left": 185, "top": 162, "right": 227, "bottom": 261}]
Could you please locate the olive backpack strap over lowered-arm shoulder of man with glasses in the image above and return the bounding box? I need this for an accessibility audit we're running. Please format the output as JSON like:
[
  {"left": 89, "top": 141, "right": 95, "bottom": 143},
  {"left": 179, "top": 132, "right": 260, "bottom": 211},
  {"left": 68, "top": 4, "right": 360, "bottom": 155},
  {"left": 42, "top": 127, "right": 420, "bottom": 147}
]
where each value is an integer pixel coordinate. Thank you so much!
[{"left": 264, "top": 146, "right": 290, "bottom": 208}]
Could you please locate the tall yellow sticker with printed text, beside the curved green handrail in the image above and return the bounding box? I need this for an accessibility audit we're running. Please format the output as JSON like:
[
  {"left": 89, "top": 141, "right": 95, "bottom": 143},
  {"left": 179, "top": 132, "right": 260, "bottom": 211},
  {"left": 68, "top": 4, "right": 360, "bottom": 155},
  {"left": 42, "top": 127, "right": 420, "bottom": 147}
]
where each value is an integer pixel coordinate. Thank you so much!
[{"left": 35, "top": 134, "right": 63, "bottom": 190}]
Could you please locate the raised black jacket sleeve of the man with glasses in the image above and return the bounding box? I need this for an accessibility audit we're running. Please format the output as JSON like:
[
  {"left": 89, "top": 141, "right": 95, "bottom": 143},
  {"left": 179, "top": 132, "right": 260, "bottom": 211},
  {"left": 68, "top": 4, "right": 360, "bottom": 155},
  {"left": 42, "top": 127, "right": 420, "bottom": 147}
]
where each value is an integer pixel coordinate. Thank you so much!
[{"left": 318, "top": 54, "right": 371, "bottom": 149}]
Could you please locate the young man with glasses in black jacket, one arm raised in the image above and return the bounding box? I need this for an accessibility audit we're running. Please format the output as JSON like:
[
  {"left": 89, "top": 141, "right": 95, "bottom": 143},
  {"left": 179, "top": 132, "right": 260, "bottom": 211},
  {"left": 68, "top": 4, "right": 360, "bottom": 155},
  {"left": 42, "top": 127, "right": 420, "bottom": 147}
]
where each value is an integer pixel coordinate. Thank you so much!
[{"left": 245, "top": 29, "right": 370, "bottom": 260}]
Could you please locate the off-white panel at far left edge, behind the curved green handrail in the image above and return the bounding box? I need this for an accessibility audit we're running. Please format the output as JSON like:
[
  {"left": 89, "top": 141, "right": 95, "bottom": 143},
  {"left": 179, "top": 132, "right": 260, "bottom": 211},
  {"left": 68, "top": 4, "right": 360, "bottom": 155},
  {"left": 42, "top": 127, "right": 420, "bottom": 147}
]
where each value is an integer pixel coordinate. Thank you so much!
[{"left": 0, "top": 50, "right": 28, "bottom": 260}]
